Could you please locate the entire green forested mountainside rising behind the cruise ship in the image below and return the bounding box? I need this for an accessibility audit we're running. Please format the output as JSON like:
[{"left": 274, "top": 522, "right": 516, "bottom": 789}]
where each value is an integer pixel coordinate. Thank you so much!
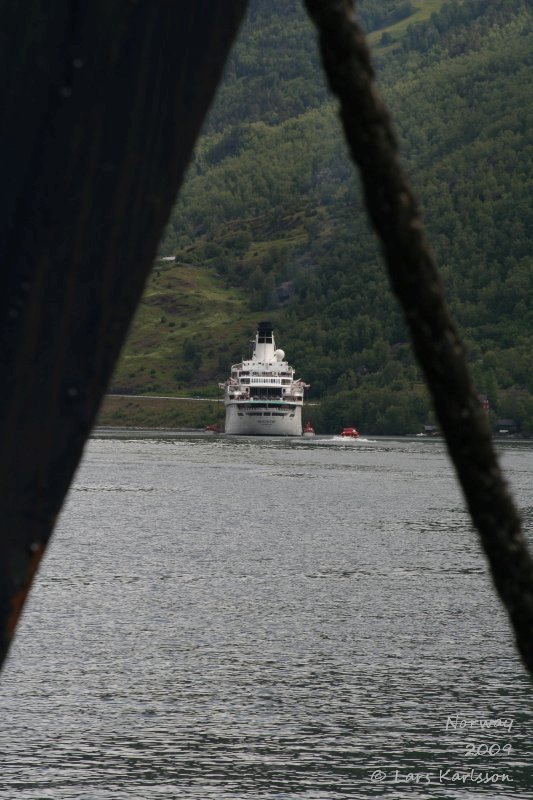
[{"left": 109, "top": 0, "right": 533, "bottom": 433}]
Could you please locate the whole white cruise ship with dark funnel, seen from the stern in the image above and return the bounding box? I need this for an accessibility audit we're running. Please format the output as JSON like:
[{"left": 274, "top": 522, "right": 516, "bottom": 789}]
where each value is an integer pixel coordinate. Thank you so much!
[{"left": 219, "top": 322, "right": 309, "bottom": 436}]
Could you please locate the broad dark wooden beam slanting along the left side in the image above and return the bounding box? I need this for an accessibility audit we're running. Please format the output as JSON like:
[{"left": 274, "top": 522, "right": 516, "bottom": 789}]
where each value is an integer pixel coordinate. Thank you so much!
[{"left": 0, "top": 0, "right": 246, "bottom": 661}]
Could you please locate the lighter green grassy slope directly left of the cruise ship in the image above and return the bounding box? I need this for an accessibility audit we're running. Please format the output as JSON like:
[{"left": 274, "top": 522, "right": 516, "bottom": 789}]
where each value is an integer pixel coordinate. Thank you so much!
[{"left": 111, "top": 261, "right": 255, "bottom": 396}]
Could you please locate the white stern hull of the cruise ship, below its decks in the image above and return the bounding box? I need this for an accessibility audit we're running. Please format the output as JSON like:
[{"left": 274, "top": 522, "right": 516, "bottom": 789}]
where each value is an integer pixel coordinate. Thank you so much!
[{"left": 225, "top": 403, "right": 302, "bottom": 436}]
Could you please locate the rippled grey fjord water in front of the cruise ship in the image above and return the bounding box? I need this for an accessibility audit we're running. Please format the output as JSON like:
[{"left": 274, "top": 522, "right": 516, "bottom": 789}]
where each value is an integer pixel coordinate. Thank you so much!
[{"left": 0, "top": 436, "right": 533, "bottom": 800}]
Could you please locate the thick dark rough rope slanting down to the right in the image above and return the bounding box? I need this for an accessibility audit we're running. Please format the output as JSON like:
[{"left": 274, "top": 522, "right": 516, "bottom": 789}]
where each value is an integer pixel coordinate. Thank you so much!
[{"left": 305, "top": 0, "right": 533, "bottom": 675}]
